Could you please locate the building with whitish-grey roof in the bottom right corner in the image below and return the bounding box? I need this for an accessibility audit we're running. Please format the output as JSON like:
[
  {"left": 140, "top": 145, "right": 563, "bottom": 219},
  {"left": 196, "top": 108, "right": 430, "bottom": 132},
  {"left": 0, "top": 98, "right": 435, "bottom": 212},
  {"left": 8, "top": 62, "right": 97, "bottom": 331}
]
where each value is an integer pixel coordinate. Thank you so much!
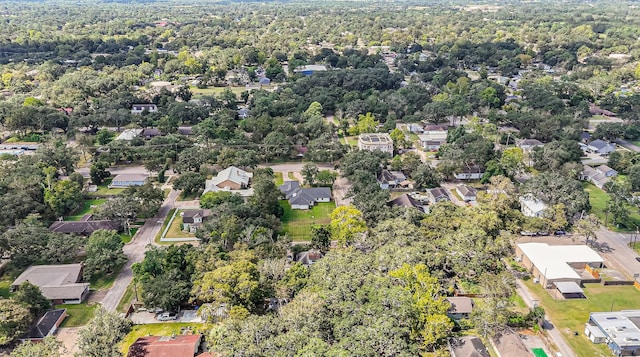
[{"left": 584, "top": 310, "right": 640, "bottom": 356}]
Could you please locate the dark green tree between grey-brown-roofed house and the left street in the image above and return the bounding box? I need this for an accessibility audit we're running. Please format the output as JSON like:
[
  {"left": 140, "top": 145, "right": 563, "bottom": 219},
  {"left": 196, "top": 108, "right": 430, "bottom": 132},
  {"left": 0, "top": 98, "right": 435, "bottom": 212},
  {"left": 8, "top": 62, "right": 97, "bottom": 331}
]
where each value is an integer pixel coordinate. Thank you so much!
[{"left": 83, "top": 230, "right": 127, "bottom": 280}]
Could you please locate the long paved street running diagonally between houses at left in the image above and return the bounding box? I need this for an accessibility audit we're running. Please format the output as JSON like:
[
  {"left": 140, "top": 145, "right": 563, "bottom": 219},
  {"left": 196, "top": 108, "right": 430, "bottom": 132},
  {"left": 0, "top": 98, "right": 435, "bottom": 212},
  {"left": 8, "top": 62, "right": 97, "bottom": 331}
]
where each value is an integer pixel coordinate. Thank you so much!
[{"left": 102, "top": 190, "right": 179, "bottom": 311}]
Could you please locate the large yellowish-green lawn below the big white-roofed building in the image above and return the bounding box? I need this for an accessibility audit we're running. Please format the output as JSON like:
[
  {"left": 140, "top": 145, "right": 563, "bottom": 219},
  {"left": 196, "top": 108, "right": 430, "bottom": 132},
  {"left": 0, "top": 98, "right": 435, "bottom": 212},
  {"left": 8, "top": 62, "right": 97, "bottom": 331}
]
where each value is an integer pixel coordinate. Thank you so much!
[{"left": 524, "top": 280, "right": 640, "bottom": 356}]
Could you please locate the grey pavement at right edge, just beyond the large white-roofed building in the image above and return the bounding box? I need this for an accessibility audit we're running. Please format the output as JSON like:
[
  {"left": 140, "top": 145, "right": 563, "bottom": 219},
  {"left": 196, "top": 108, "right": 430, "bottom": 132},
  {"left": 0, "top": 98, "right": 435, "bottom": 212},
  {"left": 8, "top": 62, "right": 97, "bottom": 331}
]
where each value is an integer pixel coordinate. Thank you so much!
[{"left": 593, "top": 228, "right": 640, "bottom": 279}]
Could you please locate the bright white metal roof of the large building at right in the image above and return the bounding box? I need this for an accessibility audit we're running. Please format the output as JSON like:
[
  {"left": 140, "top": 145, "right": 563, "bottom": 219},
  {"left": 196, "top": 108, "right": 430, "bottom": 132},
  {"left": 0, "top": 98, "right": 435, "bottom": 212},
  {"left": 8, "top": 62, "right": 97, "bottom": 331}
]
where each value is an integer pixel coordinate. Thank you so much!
[{"left": 518, "top": 243, "right": 604, "bottom": 280}]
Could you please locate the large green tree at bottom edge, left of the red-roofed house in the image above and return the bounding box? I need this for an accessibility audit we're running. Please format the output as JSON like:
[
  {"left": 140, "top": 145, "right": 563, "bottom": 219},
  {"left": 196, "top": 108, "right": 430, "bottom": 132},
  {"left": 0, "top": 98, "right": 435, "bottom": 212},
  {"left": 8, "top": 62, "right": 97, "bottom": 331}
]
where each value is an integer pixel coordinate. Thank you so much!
[{"left": 76, "top": 308, "right": 131, "bottom": 357}]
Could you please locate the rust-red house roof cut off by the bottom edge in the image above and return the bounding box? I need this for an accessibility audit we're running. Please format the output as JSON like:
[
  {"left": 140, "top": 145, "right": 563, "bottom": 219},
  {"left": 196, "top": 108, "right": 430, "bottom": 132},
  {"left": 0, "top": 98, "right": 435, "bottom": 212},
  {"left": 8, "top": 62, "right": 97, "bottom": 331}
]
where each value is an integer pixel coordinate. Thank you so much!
[{"left": 127, "top": 335, "right": 202, "bottom": 357}]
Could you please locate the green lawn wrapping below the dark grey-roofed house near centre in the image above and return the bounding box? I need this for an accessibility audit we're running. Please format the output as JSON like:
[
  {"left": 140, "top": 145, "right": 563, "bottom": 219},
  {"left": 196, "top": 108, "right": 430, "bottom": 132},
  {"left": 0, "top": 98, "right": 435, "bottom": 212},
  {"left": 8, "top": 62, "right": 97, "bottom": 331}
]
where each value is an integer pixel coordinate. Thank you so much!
[{"left": 280, "top": 200, "right": 336, "bottom": 242}]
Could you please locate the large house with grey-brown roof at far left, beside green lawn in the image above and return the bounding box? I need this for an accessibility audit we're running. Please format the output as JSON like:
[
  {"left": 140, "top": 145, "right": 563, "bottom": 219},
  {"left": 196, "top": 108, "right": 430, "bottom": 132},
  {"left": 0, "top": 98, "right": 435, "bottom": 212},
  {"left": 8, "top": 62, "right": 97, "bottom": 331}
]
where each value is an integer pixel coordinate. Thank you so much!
[{"left": 11, "top": 264, "right": 89, "bottom": 305}]
